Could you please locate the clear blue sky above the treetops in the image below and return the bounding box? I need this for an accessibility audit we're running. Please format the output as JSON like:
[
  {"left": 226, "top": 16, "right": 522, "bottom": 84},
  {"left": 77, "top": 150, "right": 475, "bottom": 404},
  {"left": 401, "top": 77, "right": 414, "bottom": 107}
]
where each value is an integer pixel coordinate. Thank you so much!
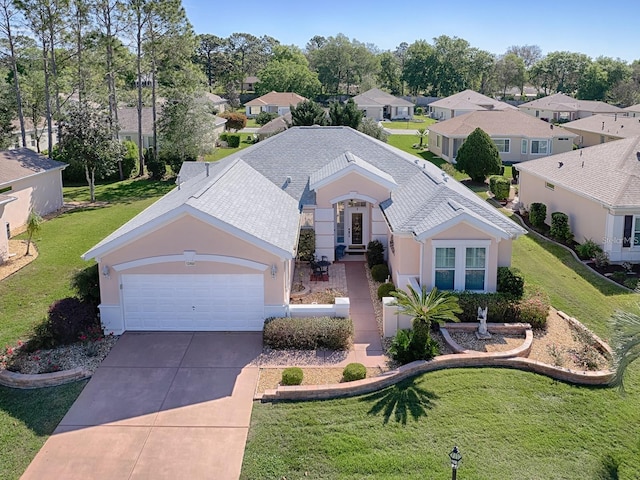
[{"left": 182, "top": 0, "right": 640, "bottom": 62}]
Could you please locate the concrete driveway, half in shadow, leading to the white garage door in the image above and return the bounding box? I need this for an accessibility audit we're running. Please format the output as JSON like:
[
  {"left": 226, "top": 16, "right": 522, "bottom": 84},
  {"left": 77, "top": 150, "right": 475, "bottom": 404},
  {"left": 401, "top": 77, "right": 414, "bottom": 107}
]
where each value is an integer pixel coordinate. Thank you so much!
[{"left": 22, "top": 332, "right": 262, "bottom": 480}]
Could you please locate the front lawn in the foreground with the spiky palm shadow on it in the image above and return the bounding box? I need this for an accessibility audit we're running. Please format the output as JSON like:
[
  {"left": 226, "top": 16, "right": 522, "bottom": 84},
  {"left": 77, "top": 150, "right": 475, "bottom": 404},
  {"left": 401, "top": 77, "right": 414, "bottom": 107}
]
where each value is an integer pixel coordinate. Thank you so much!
[{"left": 241, "top": 369, "right": 640, "bottom": 480}]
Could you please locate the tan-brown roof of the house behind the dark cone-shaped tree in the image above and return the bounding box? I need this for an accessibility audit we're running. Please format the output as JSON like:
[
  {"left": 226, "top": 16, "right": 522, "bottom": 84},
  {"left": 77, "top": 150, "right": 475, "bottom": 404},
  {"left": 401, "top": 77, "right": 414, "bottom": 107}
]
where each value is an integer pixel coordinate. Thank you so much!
[{"left": 429, "top": 110, "right": 577, "bottom": 138}]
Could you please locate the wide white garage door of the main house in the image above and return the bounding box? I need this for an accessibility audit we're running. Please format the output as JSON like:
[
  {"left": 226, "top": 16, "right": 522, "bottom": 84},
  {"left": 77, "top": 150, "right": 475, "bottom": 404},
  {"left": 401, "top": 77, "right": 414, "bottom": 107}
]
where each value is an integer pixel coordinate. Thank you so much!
[{"left": 122, "top": 274, "right": 264, "bottom": 331}]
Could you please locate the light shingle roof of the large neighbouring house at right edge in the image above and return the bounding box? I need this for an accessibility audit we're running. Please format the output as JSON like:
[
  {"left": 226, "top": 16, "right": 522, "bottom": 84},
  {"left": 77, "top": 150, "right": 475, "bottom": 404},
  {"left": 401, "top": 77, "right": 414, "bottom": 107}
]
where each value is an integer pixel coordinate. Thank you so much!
[{"left": 516, "top": 137, "right": 640, "bottom": 207}]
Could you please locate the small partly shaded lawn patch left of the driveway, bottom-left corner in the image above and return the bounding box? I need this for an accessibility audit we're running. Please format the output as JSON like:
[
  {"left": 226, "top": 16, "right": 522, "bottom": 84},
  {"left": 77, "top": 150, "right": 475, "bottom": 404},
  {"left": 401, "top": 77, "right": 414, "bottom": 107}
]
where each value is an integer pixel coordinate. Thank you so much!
[{"left": 0, "top": 381, "right": 87, "bottom": 480}]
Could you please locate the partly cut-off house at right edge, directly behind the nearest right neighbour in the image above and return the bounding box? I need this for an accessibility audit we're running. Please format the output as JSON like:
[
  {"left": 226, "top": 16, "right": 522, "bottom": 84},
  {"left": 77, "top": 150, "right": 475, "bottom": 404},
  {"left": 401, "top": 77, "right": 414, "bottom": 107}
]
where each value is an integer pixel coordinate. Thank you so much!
[{"left": 562, "top": 114, "right": 640, "bottom": 147}]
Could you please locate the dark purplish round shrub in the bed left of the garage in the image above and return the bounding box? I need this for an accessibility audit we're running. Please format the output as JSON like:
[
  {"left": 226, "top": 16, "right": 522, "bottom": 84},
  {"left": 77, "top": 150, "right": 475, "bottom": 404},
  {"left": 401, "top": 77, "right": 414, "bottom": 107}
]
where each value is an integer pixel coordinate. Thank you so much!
[{"left": 48, "top": 297, "right": 100, "bottom": 345}]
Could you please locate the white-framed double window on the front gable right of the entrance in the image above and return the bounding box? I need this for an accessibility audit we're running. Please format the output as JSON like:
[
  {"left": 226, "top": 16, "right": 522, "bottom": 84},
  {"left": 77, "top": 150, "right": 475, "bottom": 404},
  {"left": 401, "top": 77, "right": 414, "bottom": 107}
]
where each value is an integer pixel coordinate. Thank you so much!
[{"left": 432, "top": 240, "right": 490, "bottom": 292}]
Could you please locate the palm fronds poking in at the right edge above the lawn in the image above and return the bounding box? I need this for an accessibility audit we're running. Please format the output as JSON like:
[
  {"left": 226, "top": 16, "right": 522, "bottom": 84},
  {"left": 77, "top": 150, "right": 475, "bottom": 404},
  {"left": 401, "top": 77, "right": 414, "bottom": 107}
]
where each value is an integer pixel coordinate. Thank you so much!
[{"left": 611, "top": 311, "right": 640, "bottom": 392}]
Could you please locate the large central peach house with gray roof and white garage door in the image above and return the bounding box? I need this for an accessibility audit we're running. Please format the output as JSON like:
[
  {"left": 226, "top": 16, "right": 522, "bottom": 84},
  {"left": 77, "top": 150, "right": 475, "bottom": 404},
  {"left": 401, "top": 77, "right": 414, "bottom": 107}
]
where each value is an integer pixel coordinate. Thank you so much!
[{"left": 83, "top": 127, "right": 525, "bottom": 332}]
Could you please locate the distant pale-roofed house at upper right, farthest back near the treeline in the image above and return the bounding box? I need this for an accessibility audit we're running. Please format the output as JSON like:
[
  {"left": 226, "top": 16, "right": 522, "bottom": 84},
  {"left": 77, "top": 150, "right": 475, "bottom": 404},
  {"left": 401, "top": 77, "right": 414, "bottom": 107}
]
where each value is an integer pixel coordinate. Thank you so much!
[{"left": 518, "top": 93, "right": 624, "bottom": 122}]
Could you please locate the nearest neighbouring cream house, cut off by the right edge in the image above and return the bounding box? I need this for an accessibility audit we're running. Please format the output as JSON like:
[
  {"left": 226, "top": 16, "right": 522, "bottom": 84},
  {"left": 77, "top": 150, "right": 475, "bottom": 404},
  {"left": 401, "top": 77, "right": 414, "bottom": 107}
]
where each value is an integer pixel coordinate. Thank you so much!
[{"left": 515, "top": 137, "right": 640, "bottom": 263}]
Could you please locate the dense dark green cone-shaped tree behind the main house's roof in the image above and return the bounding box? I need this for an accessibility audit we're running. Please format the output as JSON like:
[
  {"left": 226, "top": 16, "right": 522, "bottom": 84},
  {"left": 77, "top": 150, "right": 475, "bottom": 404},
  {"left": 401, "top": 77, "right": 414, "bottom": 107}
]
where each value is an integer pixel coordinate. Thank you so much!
[{"left": 456, "top": 128, "right": 502, "bottom": 182}]
